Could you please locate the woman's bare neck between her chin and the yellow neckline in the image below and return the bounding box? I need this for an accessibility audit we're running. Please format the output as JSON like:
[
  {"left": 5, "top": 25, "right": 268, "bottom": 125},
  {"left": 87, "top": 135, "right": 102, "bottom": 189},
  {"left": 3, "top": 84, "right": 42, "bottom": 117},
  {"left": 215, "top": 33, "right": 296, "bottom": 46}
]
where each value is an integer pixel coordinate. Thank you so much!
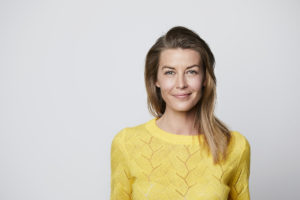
[{"left": 156, "top": 110, "right": 198, "bottom": 135}]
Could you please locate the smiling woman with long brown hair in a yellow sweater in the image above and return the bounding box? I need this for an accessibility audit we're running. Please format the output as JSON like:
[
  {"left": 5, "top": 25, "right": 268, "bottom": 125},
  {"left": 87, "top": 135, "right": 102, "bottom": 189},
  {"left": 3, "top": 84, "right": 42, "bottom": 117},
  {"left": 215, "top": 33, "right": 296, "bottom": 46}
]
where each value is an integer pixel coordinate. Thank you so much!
[{"left": 110, "top": 26, "right": 250, "bottom": 200}]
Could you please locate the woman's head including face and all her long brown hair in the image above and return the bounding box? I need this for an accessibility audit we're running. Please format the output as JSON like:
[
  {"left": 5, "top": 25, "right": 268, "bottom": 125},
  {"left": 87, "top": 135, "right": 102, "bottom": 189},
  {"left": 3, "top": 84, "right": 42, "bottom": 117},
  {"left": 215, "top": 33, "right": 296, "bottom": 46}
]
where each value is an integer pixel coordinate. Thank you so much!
[{"left": 145, "top": 26, "right": 231, "bottom": 163}]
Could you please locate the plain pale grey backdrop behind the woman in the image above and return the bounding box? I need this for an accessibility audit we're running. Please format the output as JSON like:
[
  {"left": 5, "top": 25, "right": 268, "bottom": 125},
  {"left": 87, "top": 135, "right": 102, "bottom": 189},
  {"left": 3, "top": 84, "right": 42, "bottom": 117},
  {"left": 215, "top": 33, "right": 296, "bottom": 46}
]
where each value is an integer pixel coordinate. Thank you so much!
[{"left": 0, "top": 0, "right": 300, "bottom": 200}]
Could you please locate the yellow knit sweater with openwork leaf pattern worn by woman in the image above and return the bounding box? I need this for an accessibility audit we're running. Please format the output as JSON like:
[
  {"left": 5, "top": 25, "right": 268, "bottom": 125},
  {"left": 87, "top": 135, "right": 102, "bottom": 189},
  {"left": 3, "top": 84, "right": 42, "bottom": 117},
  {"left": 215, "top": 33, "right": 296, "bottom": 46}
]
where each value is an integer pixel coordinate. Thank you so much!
[{"left": 110, "top": 118, "right": 250, "bottom": 200}]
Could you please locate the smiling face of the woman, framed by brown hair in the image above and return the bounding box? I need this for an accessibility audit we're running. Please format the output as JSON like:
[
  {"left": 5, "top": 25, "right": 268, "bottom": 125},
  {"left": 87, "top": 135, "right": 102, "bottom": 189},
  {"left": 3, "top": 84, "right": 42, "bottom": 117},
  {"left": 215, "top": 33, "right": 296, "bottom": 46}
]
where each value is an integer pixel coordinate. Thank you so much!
[{"left": 155, "top": 48, "right": 205, "bottom": 112}]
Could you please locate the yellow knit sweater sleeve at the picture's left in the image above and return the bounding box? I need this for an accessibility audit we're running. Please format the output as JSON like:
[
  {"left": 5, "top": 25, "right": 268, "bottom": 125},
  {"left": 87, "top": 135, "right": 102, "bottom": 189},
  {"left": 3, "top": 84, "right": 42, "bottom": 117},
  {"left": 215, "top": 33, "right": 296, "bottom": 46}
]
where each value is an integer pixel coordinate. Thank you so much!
[{"left": 110, "top": 129, "right": 131, "bottom": 200}]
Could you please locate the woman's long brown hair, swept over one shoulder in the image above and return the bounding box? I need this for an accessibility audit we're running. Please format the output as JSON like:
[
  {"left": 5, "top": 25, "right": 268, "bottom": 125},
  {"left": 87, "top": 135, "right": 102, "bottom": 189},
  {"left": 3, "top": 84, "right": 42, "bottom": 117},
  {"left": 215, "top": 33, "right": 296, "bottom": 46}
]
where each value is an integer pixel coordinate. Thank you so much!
[{"left": 145, "top": 26, "right": 231, "bottom": 164}]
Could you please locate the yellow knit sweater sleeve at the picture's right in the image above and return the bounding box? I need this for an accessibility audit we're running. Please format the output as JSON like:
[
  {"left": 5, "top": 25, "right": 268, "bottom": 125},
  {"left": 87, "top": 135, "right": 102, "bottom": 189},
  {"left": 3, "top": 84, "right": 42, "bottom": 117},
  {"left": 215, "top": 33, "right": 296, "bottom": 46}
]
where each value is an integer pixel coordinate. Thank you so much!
[{"left": 229, "top": 138, "right": 250, "bottom": 200}]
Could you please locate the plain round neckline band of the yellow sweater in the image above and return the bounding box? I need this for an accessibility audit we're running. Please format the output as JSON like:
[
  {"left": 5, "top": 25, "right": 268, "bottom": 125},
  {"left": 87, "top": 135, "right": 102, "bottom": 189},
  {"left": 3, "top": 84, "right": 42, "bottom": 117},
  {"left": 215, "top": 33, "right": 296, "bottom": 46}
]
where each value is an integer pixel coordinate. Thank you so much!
[{"left": 146, "top": 118, "right": 204, "bottom": 145}]
